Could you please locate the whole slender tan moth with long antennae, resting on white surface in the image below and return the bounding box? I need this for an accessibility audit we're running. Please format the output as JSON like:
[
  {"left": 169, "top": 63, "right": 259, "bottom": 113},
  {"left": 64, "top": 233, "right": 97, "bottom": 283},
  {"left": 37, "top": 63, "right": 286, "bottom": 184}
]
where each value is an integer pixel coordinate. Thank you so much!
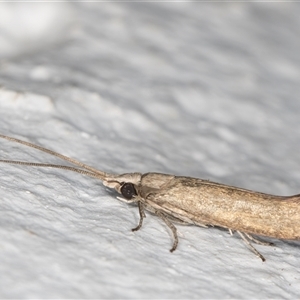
[{"left": 0, "top": 134, "right": 300, "bottom": 261}]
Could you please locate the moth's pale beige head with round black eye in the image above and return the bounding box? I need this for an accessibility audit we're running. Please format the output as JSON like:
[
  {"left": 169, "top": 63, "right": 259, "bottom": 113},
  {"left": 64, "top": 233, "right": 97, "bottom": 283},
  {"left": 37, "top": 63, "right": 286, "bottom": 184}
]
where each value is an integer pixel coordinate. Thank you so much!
[{"left": 103, "top": 173, "right": 142, "bottom": 200}]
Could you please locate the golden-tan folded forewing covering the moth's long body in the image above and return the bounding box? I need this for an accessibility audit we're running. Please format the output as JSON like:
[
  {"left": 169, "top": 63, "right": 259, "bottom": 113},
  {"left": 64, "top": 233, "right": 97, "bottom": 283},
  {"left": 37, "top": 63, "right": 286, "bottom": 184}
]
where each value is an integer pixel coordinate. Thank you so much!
[{"left": 141, "top": 177, "right": 300, "bottom": 239}]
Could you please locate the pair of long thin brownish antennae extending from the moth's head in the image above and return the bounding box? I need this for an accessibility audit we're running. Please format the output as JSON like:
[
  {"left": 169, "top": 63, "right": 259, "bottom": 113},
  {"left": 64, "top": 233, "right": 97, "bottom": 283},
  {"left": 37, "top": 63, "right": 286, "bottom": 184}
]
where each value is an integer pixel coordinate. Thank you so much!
[{"left": 0, "top": 134, "right": 111, "bottom": 180}]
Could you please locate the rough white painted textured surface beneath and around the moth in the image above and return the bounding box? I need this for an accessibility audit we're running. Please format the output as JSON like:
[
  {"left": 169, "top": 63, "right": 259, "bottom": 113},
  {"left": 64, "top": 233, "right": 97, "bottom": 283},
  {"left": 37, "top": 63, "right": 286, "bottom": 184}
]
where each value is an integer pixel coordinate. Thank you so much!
[{"left": 0, "top": 3, "right": 300, "bottom": 299}]
